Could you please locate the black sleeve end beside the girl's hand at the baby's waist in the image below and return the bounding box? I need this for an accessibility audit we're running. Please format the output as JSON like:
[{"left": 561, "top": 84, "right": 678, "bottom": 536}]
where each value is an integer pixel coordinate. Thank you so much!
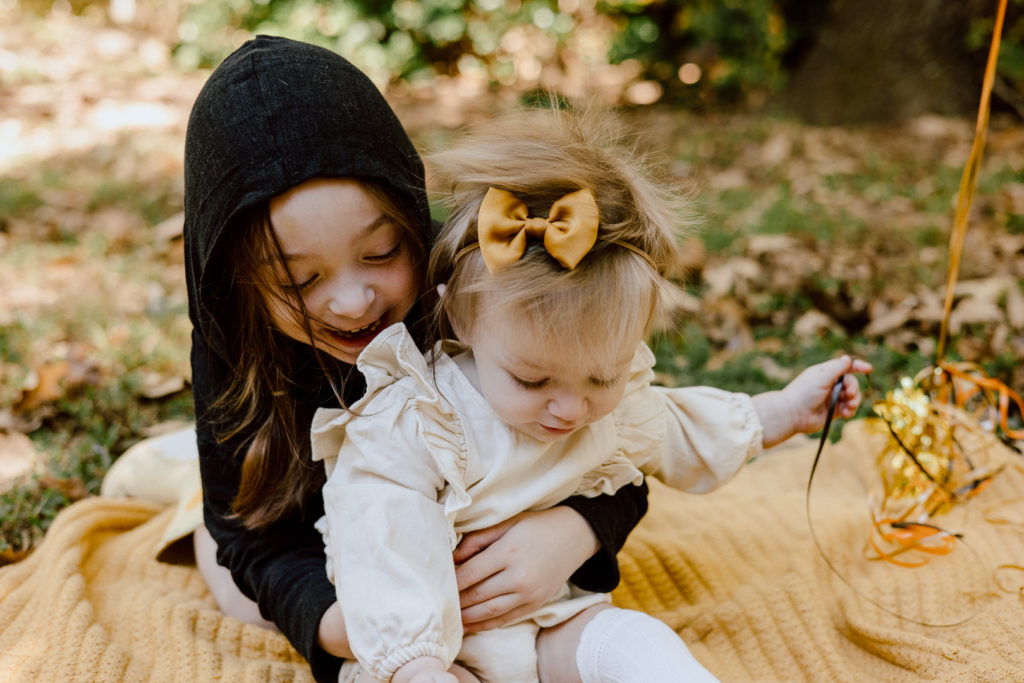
[{"left": 561, "top": 482, "right": 648, "bottom": 593}]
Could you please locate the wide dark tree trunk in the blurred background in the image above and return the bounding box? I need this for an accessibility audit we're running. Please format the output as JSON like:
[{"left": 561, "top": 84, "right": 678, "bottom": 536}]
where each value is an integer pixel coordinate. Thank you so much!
[{"left": 780, "top": 0, "right": 997, "bottom": 125}]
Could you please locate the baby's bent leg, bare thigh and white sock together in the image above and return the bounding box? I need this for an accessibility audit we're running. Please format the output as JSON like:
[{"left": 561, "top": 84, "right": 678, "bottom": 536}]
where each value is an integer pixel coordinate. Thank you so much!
[{"left": 537, "top": 605, "right": 717, "bottom": 683}]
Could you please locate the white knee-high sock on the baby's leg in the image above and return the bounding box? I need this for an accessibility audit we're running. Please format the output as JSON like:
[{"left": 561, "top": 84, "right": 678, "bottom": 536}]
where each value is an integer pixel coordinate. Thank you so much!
[{"left": 575, "top": 608, "right": 718, "bottom": 683}]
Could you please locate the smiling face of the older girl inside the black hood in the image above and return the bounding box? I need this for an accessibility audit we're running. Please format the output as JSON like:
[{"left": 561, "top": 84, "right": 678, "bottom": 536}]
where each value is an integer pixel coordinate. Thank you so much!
[{"left": 268, "top": 178, "right": 420, "bottom": 364}]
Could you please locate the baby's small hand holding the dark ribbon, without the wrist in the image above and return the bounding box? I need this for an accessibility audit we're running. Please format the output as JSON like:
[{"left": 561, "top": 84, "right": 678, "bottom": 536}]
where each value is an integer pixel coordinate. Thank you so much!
[{"left": 782, "top": 355, "right": 871, "bottom": 434}]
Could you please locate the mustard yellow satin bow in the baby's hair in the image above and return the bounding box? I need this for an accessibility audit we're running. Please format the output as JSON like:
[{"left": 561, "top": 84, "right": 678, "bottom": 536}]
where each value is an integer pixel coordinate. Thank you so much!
[{"left": 476, "top": 187, "right": 600, "bottom": 273}]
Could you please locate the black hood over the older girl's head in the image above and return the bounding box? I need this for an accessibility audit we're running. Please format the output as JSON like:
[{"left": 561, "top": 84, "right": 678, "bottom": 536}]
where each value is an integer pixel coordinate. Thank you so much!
[{"left": 184, "top": 36, "right": 430, "bottom": 355}]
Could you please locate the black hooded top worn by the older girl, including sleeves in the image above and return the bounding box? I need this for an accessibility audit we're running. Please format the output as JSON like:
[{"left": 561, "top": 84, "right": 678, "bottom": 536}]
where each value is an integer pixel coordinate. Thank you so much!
[{"left": 184, "top": 36, "right": 647, "bottom": 681}]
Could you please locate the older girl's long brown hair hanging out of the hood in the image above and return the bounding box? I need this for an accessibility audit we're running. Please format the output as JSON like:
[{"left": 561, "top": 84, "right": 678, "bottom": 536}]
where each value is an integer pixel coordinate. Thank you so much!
[{"left": 212, "top": 180, "right": 427, "bottom": 529}]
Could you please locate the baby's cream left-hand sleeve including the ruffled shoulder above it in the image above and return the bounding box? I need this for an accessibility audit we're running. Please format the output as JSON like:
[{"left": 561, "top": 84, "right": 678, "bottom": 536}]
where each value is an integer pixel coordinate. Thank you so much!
[{"left": 311, "top": 331, "right": 468, "bottom": 680}]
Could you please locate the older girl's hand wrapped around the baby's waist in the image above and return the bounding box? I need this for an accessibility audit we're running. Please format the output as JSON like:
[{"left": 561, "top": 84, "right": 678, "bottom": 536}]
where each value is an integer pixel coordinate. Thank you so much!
[{"left": 455, "top": 506, "right": 600, "bottom": 633}]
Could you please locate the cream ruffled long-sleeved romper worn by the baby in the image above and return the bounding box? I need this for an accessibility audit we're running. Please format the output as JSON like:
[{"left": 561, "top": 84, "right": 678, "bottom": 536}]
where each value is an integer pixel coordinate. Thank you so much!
[{"left": 312, "top": 323, "right": 762, "bottom": 683}]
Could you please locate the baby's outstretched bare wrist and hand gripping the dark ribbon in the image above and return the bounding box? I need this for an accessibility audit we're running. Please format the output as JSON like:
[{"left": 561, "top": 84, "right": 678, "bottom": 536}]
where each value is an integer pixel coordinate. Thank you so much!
[{"left": 754, "top": 355, "right": 871, "bottom": 449}]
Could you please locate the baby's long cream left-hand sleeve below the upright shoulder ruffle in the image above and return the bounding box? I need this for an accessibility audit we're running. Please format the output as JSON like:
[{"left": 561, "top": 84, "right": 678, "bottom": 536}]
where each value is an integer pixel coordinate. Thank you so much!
[{"left": 313, "top": 404, "right": 462, "bottom": 680}]
